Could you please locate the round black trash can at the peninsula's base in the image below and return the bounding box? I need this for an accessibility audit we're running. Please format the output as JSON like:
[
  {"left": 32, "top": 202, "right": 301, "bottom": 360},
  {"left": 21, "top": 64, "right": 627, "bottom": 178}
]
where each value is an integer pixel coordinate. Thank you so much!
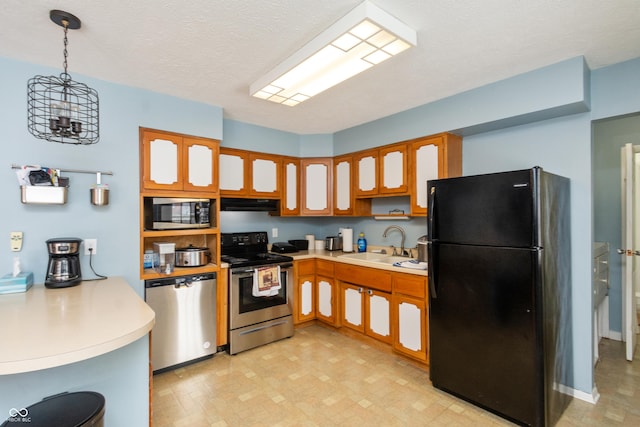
[{"left": 0, "top": 391, "right": 105, "bottom": 427}]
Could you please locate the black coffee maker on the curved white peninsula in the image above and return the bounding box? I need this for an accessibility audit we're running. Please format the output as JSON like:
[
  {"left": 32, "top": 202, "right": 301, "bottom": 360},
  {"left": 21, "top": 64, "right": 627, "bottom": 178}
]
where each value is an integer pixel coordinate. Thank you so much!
[{"left": 44, "top": 237, "right": 82, "bottom": 288}]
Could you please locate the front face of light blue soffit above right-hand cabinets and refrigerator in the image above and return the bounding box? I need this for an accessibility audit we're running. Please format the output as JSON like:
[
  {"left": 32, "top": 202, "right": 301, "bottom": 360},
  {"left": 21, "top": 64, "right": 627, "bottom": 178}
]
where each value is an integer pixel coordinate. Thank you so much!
[{"left": 334, "top": 57, "right": 590, "bottom": 155}]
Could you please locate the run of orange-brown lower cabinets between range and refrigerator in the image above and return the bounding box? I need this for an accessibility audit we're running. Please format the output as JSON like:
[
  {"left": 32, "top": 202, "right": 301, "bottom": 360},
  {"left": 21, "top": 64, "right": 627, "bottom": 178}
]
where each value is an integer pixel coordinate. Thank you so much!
[{"left": 294, "top": 258, "right": 429, "bottom": 364}]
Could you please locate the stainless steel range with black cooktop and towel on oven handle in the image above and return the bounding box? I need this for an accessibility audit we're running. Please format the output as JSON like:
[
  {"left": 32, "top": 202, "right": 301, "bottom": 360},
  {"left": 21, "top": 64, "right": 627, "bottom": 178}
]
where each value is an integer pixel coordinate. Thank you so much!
[{"left": 221, "top": 231, "right": 293, "bottom": 354}]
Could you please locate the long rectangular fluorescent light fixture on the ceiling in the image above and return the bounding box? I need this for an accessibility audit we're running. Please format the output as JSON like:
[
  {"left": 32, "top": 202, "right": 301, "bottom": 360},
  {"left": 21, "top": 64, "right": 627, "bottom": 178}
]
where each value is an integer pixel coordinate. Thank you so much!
[{"left": 249, "top": 1, "right": 417, "bottom": 106}]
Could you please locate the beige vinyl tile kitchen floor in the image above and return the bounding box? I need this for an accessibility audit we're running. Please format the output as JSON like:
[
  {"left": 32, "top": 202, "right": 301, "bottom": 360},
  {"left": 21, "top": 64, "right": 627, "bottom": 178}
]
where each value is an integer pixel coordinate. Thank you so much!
[{"left": 153, "top": 325, "right": 640, "bottom": 427}]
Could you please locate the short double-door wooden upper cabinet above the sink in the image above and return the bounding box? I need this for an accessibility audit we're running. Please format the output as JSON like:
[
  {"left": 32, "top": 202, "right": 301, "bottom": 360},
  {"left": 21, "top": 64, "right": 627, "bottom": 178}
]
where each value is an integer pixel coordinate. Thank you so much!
[{"left": 353, "top": 143, "right": 409, "bottom": 197}]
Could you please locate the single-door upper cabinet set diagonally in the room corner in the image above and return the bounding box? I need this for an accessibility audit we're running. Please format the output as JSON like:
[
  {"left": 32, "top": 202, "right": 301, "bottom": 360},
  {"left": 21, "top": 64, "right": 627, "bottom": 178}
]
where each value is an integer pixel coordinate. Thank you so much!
[{"left": 300, "top": 157, "right": 333, "bottom": 216}]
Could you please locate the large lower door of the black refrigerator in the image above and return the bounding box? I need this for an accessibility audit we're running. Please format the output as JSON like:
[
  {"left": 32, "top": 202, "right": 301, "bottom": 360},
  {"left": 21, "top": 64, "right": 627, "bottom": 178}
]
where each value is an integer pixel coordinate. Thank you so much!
[{"left": 429, "top": 244, "right": 544, "bottom": 425}]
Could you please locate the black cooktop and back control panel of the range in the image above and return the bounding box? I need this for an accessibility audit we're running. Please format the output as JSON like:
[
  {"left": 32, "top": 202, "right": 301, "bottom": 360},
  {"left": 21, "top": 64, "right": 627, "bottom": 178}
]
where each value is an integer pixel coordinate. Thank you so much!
[{"left": 220, "top": 231, "right": 293, "bottom": 267}]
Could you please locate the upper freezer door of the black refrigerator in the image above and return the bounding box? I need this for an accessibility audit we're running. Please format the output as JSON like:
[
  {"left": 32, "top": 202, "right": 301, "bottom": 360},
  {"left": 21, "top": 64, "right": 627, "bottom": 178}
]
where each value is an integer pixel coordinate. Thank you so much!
[{"left": 427, "top": 168, "right": 540, "bottom": 247}]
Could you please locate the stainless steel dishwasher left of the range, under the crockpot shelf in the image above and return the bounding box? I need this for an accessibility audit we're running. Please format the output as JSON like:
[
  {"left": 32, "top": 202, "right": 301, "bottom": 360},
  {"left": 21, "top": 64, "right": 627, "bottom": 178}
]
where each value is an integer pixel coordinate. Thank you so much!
[{"left": 144, "top": 273, "right": 216, "bottom": 372}]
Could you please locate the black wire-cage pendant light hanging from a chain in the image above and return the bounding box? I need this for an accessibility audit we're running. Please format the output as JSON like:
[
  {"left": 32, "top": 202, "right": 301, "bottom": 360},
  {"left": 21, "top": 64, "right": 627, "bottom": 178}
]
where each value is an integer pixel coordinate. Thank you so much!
[{"left": 28, "top": 10, "right": 100, "bottom": 145}]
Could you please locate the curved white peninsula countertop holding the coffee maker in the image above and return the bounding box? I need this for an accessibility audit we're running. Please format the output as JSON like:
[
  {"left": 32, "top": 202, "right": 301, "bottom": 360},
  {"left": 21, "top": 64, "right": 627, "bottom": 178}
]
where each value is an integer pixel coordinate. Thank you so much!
[{"left": 0, "top": 277, "right": 155, "bottom": 375}]
